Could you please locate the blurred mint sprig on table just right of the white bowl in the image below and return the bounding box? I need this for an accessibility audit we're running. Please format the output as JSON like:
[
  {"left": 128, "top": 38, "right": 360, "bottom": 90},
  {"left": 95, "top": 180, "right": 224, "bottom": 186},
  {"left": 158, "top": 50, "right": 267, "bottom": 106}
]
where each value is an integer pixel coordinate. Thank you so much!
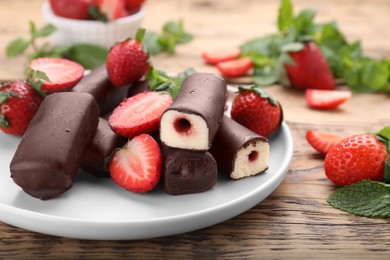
[{"left": 142, "top": 19, "right": 193, "bottom": 55}]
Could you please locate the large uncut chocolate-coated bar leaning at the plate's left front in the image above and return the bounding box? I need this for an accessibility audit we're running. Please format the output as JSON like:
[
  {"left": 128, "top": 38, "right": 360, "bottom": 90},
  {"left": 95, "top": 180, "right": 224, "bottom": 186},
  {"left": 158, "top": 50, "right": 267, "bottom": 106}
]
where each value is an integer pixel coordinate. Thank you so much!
[{"left": 10, "top": 92, "right": 99, "bottom": 200}]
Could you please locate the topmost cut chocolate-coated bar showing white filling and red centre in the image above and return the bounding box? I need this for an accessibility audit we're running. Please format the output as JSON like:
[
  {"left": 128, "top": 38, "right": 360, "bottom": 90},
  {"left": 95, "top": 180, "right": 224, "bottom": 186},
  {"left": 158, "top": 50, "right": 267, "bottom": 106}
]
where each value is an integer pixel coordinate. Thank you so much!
[{"left": 160, "top": 73, "right": 227, "bottom": 151}]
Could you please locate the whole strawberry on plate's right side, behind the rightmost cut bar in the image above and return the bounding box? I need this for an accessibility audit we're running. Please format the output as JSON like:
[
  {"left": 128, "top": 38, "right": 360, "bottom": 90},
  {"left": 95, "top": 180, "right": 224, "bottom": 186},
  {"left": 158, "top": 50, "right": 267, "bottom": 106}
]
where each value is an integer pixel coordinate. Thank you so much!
[{"left": 230, "top": 87, "right": 283, "bottom": 137}]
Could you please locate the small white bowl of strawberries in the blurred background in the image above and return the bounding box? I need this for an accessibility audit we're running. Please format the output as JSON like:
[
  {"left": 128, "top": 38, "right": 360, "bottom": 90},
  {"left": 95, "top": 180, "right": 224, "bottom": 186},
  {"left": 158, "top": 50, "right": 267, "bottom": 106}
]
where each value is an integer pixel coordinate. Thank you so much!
[{"left": 42, "top": 2, "right": 145, "bottom": 48}]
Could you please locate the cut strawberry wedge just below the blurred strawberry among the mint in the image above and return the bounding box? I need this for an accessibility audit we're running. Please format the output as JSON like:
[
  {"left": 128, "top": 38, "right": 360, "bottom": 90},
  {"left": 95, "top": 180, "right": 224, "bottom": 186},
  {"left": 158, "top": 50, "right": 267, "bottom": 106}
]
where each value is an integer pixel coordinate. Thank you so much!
[{"left": 305, "top": 89, "right": 351, "bottom": 109}]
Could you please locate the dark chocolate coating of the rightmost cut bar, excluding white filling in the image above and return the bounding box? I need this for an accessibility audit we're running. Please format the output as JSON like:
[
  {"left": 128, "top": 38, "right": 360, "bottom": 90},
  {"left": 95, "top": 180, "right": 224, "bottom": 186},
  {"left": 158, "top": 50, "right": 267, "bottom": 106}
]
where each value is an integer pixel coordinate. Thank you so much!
[{"left": 210, "top": 116, "right": 268, "bottom": 178}]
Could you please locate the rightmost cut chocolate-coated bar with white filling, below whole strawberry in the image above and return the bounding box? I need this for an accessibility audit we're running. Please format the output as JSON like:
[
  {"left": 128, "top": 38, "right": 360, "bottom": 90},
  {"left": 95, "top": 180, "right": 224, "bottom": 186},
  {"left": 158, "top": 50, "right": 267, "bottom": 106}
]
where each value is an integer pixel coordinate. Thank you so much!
[{"left": 210, "top": 116, "right": 270, "bottom": 179}]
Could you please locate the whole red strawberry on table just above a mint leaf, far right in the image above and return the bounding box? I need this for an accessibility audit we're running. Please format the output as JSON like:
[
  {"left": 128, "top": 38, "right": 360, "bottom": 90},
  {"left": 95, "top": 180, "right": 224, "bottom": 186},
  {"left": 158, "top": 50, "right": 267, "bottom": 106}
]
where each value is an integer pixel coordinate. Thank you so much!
[{"left": 324, "top": 134, "right": 387, "bottom": 186}]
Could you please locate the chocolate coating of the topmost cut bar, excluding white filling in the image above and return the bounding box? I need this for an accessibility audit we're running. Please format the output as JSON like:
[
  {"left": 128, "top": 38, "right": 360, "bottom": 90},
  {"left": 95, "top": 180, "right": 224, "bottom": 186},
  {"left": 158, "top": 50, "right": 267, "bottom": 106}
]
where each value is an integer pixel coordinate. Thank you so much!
[{"left": 162, "top": 73, "right": 227, "bottom": 147}]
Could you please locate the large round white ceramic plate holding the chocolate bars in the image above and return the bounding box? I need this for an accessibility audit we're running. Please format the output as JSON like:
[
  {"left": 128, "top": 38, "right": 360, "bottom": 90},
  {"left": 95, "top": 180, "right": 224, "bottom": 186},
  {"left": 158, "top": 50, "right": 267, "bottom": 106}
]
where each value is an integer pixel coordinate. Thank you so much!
[{"left": 0, "top": 87, "right": 293, "bottom": 240}]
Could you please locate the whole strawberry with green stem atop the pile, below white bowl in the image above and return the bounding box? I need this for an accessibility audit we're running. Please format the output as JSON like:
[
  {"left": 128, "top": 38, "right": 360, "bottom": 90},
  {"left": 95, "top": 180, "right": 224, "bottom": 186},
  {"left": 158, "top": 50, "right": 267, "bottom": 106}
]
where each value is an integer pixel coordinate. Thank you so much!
[{"left": 106, "top": 29, "right": 149, "bottom": 87}]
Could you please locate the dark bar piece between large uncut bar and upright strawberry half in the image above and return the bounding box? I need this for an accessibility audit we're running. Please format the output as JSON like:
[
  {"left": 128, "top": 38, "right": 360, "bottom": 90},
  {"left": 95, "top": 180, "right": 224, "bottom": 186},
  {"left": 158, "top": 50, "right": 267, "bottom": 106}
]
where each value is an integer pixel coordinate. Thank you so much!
[{"left": 81, "top": 118, "right": 127, "bottom": 177}]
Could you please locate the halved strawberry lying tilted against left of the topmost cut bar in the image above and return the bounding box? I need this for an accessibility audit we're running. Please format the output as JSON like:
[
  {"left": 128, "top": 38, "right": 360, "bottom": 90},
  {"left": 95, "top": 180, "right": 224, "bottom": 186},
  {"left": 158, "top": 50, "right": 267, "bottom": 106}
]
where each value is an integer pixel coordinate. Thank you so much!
[{"left": 109, "top": 92, "right": 173, "bottom": 137}]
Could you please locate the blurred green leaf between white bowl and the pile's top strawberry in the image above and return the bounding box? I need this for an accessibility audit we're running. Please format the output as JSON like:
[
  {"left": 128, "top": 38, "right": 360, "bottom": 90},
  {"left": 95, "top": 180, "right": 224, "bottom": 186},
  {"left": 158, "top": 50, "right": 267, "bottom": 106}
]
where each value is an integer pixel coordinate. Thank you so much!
[{"left": 66, "top": 44, "right": 108, "bottom": 69}]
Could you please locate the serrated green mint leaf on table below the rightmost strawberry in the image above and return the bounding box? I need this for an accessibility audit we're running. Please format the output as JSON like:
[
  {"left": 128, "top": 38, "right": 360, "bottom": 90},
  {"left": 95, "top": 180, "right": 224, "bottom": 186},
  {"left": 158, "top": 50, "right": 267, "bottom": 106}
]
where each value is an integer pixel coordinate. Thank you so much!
[{"left": 327, "top": 180, "right": 390, "bottom": 218}]
